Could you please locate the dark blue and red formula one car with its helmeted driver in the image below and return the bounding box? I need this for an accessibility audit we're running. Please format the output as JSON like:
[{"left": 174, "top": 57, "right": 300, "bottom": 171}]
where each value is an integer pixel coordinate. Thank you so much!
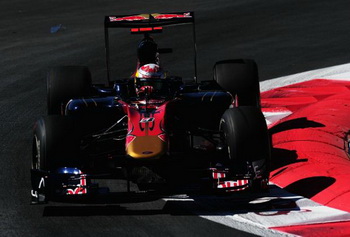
[{"left": 31, "top": 12, "right": 270, "bottom": 204}]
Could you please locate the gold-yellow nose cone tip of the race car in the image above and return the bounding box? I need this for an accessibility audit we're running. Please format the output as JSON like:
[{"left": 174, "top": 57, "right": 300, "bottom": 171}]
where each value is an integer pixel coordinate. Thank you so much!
[{"left": 126, "top": 136, "right": 167, "bottom": 159}]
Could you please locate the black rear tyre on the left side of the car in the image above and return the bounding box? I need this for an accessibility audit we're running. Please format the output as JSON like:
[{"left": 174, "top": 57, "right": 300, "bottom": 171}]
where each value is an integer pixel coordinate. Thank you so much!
[{"left": 47, "top": 66, "right": 91, "bottom": 115}]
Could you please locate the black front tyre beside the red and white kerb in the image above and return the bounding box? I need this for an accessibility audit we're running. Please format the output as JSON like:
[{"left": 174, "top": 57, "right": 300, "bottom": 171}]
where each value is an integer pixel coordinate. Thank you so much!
[{"left": 220, "top": 106, "right": 270, "bottom": 177}]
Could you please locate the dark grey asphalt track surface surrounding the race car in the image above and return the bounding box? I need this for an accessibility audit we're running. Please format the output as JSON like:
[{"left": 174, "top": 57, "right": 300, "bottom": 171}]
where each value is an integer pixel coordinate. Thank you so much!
[{"left": 0, "top": 0, "right": 350, "bottom": 236}]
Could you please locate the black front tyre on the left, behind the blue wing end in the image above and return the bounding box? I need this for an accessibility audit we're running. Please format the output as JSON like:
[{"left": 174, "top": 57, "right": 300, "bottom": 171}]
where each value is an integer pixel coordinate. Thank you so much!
[{"left": 32, "top": 115, "right": 79, "bottom": 171}]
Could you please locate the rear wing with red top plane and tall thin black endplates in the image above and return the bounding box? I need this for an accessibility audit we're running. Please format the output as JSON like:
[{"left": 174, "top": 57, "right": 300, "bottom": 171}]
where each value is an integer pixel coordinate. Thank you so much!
[{"left": 104, "top": 12, "right": 197, "bottom": 84}]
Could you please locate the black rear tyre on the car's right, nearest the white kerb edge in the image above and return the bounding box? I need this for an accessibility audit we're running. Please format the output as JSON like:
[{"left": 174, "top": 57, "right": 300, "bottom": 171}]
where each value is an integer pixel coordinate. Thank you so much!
[{"left": 214, "top": 59, "right": 260, "bottom": 107}]
